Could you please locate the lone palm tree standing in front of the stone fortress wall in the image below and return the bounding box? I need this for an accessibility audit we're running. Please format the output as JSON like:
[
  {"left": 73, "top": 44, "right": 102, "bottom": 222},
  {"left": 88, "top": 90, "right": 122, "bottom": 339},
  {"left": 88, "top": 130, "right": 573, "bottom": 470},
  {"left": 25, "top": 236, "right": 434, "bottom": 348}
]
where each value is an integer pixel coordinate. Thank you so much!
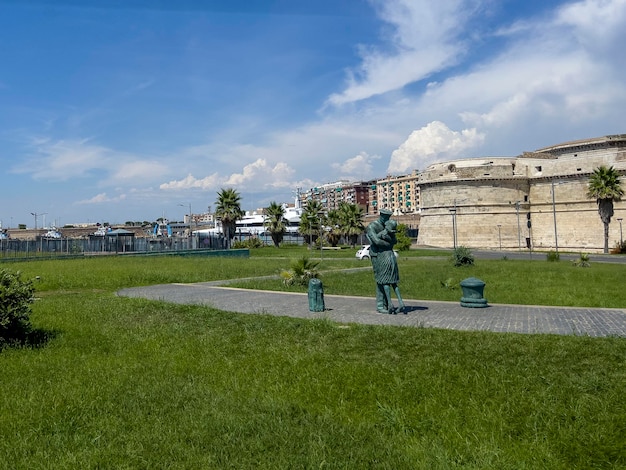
[{"left": 587, "top": 165, "right": 624, "bottom": 253}]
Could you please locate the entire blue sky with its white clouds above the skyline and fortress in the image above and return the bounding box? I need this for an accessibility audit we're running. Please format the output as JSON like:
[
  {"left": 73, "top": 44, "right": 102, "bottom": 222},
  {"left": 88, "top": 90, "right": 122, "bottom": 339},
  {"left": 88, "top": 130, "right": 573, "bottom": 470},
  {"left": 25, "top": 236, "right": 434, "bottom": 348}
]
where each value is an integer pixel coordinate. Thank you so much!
[{"left": 0, "top": 0, "right": 626, "bottom": 227}]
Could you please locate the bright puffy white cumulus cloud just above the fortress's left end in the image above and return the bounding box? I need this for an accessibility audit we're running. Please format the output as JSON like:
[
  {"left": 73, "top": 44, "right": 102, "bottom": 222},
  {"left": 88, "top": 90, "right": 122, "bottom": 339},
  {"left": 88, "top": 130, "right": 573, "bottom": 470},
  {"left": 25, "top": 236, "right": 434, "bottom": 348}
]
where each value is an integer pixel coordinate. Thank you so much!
[{"left": 389, "top": 121, "right": 484, "bottom": 174}]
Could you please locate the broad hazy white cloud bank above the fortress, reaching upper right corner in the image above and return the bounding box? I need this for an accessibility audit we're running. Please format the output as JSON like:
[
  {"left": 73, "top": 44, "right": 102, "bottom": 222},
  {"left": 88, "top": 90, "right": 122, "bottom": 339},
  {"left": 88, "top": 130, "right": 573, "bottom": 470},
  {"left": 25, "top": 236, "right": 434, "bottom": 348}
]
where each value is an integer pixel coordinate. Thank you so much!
[{"left": 382, "top": 0, "right": 626, "bottom": 157}]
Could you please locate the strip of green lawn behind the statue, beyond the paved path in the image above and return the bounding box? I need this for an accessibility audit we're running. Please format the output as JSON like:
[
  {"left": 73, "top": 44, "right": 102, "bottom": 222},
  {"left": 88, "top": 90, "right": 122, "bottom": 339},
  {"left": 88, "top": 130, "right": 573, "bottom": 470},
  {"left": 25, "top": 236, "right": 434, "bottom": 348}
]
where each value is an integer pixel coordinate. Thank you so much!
[{"left": 232, "top": 251, "right": 626, "bottom": 308}]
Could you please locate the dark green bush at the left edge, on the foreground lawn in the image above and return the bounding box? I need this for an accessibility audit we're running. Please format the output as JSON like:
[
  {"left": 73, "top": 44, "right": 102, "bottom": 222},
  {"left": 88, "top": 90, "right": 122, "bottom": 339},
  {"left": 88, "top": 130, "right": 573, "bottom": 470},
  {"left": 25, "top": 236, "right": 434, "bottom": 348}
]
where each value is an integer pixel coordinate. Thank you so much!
[{"left": 0, "top": 269, "right": 35, "bottom": 347}]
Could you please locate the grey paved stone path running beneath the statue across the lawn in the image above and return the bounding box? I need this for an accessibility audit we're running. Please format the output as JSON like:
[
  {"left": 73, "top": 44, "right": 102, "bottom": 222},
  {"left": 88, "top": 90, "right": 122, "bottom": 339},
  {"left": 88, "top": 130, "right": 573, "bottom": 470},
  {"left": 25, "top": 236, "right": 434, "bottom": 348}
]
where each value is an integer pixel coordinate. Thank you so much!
[{"left": 118, "top": 282, "right": 626, "bottom": 337}]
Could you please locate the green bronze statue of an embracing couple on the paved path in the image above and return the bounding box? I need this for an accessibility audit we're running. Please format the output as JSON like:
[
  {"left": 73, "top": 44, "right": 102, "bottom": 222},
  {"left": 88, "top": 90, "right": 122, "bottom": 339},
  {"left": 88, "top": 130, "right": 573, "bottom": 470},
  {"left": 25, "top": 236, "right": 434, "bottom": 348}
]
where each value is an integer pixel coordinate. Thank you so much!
[{"left": 366, "top": 209, "right": 406, "bottom": 313}]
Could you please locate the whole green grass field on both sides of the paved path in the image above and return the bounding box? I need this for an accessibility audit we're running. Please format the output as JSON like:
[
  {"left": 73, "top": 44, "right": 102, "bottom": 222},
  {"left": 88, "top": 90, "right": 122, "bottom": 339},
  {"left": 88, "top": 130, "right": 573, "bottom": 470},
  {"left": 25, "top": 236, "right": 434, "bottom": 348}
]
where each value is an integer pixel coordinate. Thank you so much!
[{"left": 0, "top": 248, "right": 626, "bottom": 469}]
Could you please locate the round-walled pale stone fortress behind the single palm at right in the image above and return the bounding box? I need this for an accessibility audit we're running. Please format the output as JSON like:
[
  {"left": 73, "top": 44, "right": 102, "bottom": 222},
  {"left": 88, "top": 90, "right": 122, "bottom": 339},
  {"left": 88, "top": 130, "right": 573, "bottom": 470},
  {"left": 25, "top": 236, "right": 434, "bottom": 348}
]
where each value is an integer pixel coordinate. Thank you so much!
[{"left": 417, "top": 134, "right": 626, "bottom": 252}]
